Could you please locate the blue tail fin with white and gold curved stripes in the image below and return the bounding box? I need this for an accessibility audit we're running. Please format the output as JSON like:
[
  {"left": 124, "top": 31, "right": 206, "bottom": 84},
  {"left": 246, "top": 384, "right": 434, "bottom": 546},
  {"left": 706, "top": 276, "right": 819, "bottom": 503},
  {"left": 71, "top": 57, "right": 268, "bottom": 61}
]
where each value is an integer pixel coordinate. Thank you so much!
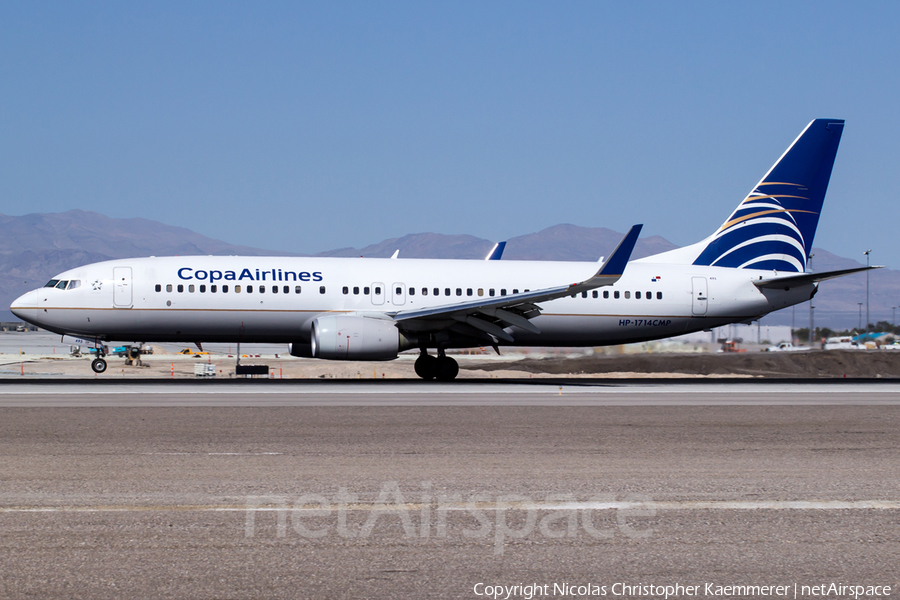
[{"left": 694, "top": 119, "right": 844, "bottom": 273}]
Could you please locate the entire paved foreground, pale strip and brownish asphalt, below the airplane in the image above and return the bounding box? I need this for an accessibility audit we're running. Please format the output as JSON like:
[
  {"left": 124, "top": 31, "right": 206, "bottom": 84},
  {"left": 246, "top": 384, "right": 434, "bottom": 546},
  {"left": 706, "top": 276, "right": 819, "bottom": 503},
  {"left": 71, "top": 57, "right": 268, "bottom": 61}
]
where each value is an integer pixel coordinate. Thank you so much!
[{"left": 0, "top": 380, "right": 900, "bottom": 598}]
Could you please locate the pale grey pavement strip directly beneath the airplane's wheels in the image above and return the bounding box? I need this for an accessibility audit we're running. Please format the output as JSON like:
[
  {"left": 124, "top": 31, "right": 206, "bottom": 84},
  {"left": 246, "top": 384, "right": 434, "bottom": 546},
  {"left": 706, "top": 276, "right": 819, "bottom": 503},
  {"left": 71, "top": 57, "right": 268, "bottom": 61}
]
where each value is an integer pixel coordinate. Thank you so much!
[{"left": 0, "top": 379, "right": 900, "bottom": 408}]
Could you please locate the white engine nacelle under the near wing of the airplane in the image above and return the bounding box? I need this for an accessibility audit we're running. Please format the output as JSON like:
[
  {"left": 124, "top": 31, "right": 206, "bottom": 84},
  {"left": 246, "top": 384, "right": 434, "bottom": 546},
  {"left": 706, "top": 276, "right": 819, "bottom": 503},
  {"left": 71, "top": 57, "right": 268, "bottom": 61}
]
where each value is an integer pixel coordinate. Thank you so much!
[{"left": 311, "top": 316, "right": 401, "bottom": 360}]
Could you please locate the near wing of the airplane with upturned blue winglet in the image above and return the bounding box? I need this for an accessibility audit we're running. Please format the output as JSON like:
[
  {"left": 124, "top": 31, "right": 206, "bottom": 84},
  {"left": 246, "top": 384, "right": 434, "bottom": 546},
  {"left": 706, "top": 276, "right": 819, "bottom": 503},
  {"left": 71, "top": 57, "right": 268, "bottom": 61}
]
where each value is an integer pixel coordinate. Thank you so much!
[{"left": 387, "top": 225, "right": 643, "bottom": 342}]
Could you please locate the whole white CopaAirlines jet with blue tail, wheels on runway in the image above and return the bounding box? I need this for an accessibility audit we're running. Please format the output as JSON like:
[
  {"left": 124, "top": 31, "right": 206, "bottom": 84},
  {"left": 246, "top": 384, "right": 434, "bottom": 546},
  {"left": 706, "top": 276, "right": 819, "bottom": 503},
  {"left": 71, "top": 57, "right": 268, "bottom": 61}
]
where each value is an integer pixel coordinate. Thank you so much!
[{"left": 10, "top": 119, "right": 865, "bottom": 380}]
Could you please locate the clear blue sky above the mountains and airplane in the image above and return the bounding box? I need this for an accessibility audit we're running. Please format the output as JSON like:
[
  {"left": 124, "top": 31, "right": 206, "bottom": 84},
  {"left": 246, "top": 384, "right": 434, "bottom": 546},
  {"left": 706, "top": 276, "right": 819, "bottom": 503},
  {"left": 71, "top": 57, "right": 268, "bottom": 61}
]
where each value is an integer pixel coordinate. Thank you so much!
[{"left": 0, "top": 2, "right": 900, "bottom": 268}]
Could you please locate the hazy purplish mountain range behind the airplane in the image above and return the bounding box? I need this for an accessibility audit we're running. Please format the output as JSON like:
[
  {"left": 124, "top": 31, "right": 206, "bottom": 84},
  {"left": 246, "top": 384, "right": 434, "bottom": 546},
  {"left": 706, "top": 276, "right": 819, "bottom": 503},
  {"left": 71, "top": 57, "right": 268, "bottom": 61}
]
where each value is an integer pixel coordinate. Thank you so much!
[{"left": 0, "top": 210, "right": 900, "bottom": 329}]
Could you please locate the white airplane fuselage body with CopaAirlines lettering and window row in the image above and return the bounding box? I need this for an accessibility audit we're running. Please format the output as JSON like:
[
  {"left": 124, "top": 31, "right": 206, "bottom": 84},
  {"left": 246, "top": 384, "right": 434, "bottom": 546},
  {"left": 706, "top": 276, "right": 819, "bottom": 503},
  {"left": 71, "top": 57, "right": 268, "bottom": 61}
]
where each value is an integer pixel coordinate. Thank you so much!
[{"left": 11, "top": 256, "right": 815, "bottom": 346}]
